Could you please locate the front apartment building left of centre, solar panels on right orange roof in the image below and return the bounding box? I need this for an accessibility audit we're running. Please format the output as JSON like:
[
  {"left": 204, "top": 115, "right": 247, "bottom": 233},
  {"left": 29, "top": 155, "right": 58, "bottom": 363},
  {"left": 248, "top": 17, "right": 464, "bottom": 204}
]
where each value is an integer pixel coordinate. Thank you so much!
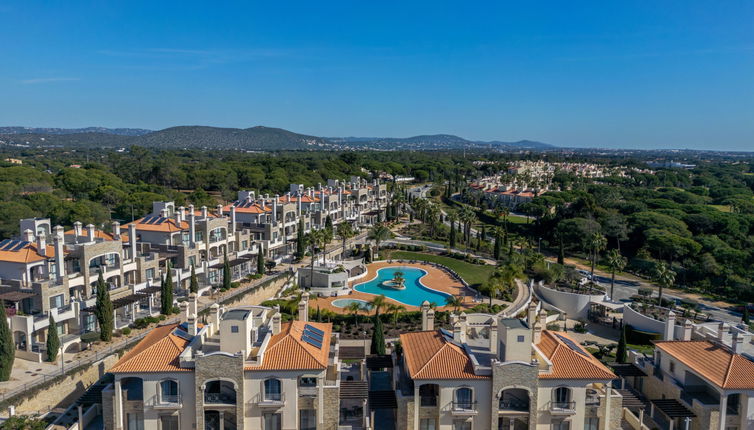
[{"left": 102, "top": 297, "right": 340, "bottom": 430}]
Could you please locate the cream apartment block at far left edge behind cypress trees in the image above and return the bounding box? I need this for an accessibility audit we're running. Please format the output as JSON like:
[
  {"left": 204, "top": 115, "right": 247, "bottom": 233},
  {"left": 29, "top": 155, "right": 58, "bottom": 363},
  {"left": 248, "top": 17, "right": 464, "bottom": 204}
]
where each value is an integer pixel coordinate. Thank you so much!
[{"left": 0, "top": 218, "right": 159, "bottom": 361}]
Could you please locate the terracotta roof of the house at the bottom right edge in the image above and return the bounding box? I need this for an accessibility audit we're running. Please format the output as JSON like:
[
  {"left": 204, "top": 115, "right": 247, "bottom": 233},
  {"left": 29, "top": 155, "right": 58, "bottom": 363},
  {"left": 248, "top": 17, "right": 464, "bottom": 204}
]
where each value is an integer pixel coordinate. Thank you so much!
[{"left": 655, "top": 341, "right": 754, "bottom": 390}]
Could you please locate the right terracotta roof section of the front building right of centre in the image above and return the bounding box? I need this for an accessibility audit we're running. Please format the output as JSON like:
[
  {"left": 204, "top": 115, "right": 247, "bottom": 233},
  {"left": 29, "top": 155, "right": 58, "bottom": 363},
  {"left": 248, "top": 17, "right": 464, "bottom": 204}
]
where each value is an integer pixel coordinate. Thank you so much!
[{"left": 537, "top": 330, "right": 616, "bottom": 380}]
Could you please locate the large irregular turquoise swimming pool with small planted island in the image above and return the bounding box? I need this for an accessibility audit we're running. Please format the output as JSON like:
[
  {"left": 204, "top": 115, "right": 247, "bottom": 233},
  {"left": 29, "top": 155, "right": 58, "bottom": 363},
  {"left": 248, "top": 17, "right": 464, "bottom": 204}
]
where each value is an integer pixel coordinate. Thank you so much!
[{"left": 353, "top": 266, "right": 450, "bottom": 307}]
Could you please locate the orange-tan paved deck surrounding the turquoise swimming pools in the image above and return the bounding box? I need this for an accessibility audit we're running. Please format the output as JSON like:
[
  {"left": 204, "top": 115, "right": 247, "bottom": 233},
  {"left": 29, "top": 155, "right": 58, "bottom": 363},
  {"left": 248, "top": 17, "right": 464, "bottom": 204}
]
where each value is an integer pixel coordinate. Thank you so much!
[{"left": 309, "top": 261, "right": 478, "bottom": 315}]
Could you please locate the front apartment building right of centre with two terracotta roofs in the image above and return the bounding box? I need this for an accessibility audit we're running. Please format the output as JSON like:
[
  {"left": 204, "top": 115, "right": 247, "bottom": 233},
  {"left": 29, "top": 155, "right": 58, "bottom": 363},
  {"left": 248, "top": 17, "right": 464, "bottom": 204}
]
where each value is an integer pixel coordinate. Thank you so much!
[{"left": 395, "top": 303, "right": 622, "bottom": 430}]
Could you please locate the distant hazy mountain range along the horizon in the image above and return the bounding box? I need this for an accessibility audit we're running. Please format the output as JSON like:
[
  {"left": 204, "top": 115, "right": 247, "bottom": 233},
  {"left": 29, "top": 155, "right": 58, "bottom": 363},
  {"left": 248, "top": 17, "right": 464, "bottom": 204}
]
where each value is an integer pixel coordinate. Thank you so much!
[{"left": 0, "top": 126, "right": 554, "bottom": 151}]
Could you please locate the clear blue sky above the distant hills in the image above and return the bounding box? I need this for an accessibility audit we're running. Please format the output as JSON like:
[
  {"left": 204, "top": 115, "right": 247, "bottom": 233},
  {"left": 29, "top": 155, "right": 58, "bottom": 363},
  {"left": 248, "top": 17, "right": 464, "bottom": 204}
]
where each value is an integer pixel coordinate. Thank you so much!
[{"left": 0, "top": 0, "right": 754, "bottom": 150}]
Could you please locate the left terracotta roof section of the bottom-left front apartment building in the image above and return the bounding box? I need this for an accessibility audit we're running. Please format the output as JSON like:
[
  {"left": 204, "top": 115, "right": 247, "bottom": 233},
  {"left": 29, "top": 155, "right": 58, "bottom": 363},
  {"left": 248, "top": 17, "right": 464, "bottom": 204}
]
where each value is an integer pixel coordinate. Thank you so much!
[{"left": 110, "top": 324, "right": 193, "bottom": 373}]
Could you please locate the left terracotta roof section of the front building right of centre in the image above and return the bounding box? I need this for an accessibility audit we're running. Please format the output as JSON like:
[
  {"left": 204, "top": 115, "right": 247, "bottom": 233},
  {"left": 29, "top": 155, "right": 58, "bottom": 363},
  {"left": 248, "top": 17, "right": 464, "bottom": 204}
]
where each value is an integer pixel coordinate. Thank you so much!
[{"left": 400, "top": 330, "right": 489, "bottom": 379}]
